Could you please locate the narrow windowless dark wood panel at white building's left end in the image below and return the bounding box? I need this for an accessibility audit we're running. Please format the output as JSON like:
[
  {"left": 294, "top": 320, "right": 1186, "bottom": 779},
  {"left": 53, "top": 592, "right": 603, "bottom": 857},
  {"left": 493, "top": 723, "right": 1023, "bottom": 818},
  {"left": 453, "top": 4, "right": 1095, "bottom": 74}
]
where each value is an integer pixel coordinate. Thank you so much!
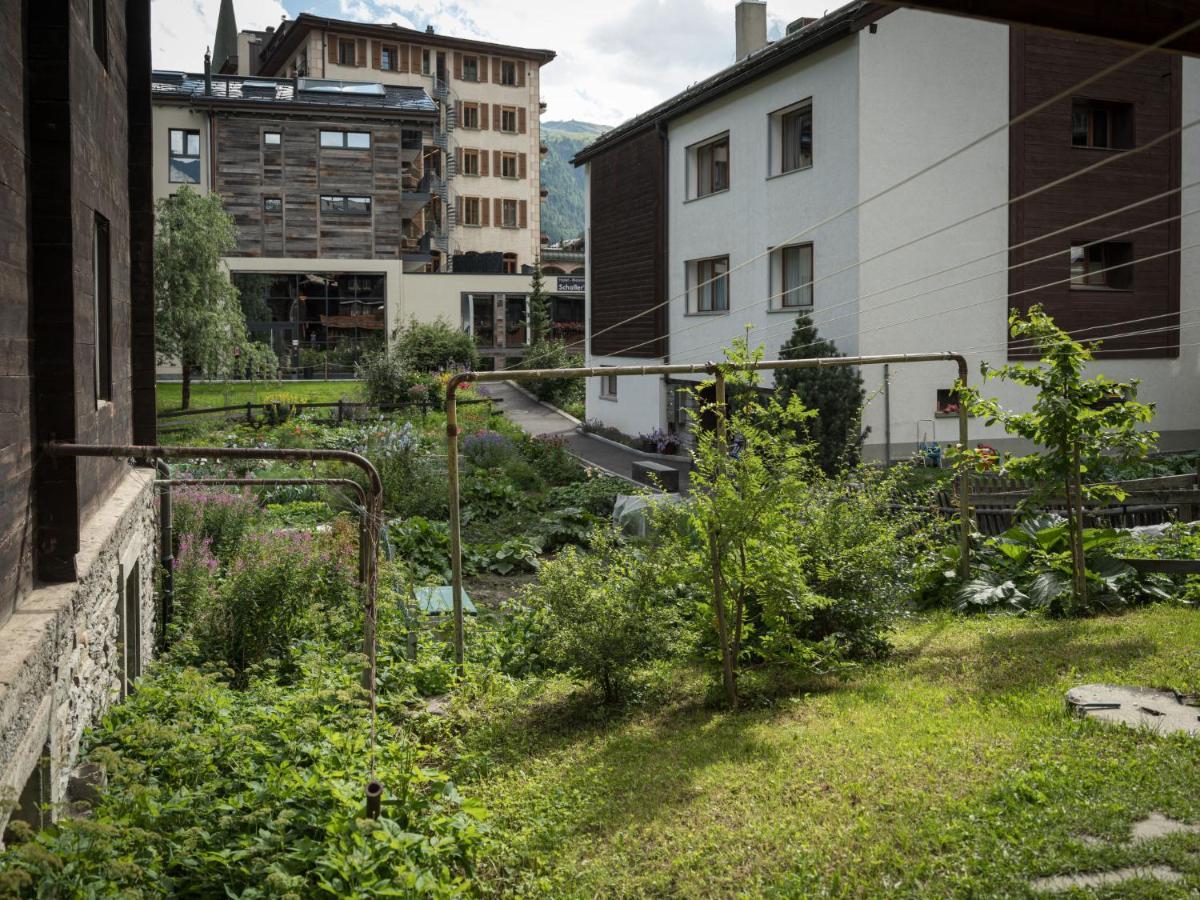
[{"left": 589, "top": 128, "right": 667, "bottom": 358}]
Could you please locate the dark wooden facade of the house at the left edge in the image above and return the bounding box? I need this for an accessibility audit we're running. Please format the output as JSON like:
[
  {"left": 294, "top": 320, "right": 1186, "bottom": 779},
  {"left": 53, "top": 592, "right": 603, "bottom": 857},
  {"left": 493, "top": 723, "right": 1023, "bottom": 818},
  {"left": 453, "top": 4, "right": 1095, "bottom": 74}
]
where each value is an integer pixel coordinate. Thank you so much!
[{"left": 0, "top": 0, "right": 155, "bottom": 623}]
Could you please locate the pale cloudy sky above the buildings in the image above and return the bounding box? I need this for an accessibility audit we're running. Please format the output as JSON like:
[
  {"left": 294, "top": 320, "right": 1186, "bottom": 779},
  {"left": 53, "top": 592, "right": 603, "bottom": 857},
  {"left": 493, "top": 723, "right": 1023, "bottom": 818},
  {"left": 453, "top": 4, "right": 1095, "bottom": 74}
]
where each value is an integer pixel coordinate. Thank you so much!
[{"left": 152, "top": 0, "right": 841, "bottom": 125}]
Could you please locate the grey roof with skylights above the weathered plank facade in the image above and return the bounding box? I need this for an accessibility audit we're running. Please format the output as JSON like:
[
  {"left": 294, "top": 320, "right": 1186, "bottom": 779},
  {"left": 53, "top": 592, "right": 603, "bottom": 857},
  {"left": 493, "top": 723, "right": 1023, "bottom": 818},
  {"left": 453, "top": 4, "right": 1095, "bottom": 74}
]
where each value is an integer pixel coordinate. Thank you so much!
[{"left": 151, "top": 70, "right": 438, "bottom": 116}]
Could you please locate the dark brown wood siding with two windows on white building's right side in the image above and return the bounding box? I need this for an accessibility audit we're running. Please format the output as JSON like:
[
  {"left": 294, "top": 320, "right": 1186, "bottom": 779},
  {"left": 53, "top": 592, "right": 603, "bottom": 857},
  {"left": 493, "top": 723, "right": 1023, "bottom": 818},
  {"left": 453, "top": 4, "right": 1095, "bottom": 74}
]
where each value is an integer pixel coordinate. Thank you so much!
[{"left": 1009, "top": 28, "right": 1182, "bottom": 358}]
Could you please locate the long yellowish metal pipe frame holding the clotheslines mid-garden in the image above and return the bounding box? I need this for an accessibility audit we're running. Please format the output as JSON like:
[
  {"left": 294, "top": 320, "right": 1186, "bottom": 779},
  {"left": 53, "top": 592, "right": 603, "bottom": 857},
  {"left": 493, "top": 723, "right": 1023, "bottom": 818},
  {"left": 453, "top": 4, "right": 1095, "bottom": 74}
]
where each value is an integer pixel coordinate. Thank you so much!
[{"left": 445, "top": 352, "right": 971, "bottom": 670}]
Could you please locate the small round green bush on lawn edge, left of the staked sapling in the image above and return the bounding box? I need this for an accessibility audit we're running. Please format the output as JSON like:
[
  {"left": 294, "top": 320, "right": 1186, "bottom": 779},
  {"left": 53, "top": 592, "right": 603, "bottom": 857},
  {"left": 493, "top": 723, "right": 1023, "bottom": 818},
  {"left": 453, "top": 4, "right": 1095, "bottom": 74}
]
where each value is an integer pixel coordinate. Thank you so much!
[{"left": 524, "top": 529, "right": 678, "bottom": 702}]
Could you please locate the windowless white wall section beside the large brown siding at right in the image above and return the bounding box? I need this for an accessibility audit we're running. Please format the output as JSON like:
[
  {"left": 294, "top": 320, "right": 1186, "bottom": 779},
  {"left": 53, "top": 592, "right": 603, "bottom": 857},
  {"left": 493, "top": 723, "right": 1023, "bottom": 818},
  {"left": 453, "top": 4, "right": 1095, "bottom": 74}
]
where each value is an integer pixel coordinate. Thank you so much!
[{"left": 854, "top": 10, "right": 1018, "bottom": 455}]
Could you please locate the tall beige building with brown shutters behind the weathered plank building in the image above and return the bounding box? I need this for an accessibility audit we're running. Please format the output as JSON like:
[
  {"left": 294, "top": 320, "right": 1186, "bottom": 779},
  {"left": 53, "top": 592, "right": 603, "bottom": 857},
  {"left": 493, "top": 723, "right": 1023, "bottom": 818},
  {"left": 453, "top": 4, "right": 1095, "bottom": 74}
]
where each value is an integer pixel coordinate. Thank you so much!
[{"left": 223, "top": 10, "right": 554, "bottom": 274}]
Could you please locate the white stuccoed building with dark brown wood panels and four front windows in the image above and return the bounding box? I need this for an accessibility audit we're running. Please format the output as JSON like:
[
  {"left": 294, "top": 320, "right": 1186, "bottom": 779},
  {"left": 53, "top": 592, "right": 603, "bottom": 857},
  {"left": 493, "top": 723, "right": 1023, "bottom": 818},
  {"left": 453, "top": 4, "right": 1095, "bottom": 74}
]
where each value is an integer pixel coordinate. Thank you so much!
[{"left": 576, "top": 2, "right": 1200, "bottom": 458}]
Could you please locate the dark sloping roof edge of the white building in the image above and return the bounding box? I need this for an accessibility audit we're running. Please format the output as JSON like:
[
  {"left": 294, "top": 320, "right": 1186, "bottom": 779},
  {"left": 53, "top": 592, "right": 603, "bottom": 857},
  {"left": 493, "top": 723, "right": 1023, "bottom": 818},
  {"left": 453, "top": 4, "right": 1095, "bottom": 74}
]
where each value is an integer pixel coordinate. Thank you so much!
[{"left": 571, "top": 0, "right": 890, "bottom": 166}]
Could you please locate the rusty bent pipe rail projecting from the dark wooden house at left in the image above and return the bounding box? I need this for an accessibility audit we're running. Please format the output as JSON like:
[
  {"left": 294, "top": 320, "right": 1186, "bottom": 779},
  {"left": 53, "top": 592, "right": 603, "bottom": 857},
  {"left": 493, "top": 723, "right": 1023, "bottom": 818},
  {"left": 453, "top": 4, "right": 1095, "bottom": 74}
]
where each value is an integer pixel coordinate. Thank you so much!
[{"left": 43, "top": 440, "right": 383, "bottom": 790}]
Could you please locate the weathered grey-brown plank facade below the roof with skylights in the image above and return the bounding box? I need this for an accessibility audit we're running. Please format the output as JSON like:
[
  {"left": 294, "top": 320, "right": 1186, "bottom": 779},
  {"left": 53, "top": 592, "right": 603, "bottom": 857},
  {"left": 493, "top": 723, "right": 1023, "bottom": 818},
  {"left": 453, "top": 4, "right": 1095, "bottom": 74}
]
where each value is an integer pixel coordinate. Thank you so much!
[{"left": 215, "top": 114, "right": 417, "bottom": 259}]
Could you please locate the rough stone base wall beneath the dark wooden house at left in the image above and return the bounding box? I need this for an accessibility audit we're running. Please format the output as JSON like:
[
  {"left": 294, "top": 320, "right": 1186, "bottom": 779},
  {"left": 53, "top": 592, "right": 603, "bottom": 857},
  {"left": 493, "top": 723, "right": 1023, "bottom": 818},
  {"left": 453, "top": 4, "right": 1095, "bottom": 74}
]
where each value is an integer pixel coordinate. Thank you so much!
[{"left": 0, "top": 468, "right": 158, "bottom": 844}]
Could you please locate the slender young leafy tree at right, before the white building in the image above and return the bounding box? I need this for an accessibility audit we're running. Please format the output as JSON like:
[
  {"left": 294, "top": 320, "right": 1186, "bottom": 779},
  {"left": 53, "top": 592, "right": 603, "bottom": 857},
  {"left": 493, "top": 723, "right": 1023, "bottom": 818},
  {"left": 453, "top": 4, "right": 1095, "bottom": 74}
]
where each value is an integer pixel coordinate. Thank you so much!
[{"left": 961, "top": 306, "right": 1158, "bottom": 612}]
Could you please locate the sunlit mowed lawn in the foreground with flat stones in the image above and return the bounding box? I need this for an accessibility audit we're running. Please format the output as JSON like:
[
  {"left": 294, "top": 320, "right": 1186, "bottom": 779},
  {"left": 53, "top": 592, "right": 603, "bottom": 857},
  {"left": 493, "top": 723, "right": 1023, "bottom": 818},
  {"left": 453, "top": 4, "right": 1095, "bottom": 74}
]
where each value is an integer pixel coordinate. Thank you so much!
[{"left": 462, "top": 606, "right": 1200, "bottom": 898}]
